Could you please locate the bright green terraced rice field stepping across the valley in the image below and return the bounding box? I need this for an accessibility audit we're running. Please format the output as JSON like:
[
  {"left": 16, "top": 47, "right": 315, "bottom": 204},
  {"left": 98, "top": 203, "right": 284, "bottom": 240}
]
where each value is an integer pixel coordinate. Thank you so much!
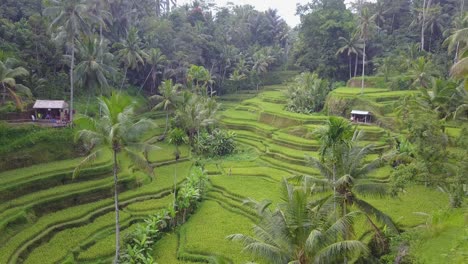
[{"left": 0, "top": 86, "right": 464, "bottom": 264}]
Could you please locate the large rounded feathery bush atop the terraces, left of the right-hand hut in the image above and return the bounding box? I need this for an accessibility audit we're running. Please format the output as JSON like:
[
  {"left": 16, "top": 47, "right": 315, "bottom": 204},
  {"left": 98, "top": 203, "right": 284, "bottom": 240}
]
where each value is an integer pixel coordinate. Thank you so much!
[{"left": 286, "top": 73, "right": 331, "bottom": 113}]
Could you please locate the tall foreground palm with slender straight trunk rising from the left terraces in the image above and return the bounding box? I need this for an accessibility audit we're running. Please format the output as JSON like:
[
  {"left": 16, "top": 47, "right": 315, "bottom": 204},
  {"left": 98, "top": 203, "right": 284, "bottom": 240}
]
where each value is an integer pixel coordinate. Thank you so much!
[{"left": 73, "top": 93, "right": 155, "bottom": 263}]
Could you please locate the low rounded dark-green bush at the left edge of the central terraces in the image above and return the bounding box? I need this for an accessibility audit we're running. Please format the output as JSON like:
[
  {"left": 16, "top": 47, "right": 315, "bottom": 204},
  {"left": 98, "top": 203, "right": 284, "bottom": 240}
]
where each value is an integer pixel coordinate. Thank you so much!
[{"left": 196, "top": 128, "right": 236, "bottom": 157}]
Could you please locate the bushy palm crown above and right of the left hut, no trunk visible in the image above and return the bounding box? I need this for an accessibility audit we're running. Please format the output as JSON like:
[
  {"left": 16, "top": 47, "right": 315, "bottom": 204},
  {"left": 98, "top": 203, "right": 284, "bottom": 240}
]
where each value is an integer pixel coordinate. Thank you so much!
[{"left": 74, "top": 37, "right": 116, "bottom": 94}]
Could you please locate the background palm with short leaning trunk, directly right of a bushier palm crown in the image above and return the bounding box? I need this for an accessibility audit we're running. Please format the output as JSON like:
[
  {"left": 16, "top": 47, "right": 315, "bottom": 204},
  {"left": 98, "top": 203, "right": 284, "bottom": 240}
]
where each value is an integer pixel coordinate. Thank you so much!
[{"left": 117, "top": 28, "right": 147, "bottom": 89}]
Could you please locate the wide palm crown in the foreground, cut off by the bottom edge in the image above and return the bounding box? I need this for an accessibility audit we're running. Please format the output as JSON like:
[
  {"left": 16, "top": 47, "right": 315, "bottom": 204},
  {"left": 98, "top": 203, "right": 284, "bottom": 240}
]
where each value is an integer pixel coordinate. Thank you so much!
[{"left": 227, "top": 180, "right": 367, "bottom": 264}]
